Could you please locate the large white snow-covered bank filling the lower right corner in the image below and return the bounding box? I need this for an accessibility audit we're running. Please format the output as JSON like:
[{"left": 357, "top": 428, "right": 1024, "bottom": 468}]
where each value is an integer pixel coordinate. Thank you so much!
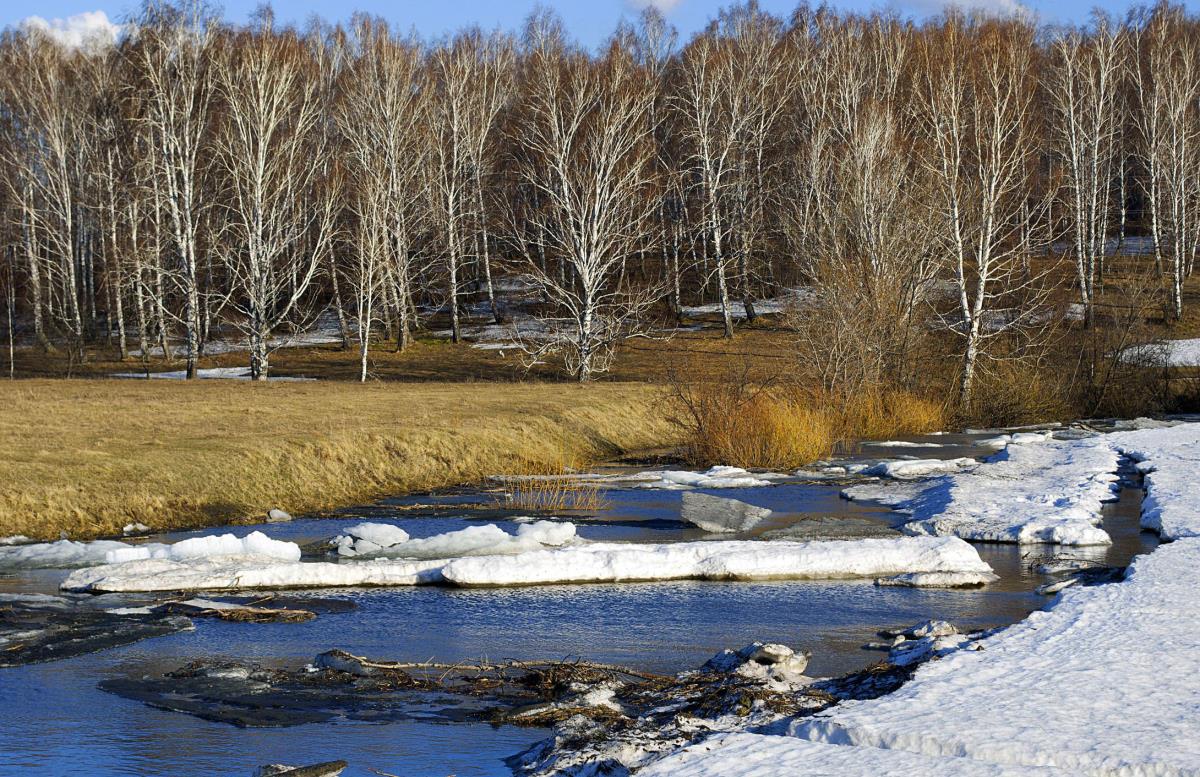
[{"left": 642, "top": 424, "right": 1200, "bottom": 777}]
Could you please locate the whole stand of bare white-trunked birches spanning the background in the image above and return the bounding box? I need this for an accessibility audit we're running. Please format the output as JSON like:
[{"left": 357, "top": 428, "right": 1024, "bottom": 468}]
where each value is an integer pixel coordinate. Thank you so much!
[{"left": 0, "top": 1, "right": 1200, "bottom": 406}]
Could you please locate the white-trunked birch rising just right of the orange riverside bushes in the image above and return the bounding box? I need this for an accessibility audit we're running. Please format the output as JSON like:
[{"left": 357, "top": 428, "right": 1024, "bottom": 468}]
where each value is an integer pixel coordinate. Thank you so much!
[{"left": 916, "top": 13, "right": 1045, "bottom": 409}]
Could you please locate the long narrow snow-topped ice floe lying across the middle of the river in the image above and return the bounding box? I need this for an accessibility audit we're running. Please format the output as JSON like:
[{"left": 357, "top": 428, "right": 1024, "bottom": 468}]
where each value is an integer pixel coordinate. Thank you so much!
[{"left": 62, "top": 534, "right": 991, "bottom": 591}]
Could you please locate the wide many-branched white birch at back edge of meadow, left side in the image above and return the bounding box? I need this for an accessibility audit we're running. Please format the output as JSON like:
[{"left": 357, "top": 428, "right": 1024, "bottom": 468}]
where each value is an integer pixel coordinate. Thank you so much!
[{"left": 215, "top": 14, "right": 337, "bottom": 380}]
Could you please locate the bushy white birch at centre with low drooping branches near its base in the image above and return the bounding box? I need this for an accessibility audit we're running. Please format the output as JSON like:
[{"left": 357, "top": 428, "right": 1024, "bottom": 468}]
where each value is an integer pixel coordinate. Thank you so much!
[{"left": 515, "top": 34, "right": 660, "bottom": 383}]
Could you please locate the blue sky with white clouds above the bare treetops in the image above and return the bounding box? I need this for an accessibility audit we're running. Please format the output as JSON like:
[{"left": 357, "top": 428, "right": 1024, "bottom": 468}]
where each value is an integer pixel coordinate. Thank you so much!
[{"left": 7, "top": 0, "right": 1200, "bottom": 44}]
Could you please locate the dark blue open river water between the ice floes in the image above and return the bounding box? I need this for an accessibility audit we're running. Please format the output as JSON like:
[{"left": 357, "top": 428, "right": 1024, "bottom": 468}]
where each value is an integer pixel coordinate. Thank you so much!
[{"left": 0, "top": 435, "right": 1154, "bottom": 777}]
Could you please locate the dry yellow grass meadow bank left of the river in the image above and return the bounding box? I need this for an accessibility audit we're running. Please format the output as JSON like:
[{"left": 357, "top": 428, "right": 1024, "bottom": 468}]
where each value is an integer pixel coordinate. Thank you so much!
[{"left": 0, "top": 380, "right": 678, "bottom": 538}]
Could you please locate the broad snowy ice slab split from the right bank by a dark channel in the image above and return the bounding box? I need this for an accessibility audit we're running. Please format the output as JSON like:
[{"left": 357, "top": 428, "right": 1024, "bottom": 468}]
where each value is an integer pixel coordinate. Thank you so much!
[{"left": 842, "top": 434, "right": 1120, "bottom": 546}]
